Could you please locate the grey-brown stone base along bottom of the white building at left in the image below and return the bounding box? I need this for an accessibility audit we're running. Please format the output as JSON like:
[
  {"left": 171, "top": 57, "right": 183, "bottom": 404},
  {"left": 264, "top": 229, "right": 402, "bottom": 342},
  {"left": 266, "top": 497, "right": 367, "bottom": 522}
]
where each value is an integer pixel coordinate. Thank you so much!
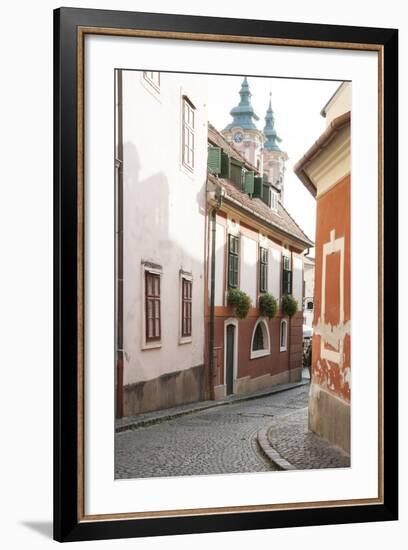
[{"left": 123, "top": 365, "right": 206, "bottom": 416}]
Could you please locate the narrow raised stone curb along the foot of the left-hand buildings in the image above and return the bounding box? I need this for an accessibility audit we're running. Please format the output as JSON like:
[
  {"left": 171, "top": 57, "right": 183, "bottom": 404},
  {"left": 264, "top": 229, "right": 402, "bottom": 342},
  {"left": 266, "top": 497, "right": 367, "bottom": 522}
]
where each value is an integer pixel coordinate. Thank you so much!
[{"left": 115, "top": 380, "right": 309, "bottom": 433}]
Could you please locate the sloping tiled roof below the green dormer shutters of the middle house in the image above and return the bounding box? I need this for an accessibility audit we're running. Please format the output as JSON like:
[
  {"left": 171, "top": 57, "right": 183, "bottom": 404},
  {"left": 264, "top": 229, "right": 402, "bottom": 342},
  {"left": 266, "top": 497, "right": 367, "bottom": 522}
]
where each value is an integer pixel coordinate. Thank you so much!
[{"left": 208, "top": 174, "right": 313, "bottom": 248}]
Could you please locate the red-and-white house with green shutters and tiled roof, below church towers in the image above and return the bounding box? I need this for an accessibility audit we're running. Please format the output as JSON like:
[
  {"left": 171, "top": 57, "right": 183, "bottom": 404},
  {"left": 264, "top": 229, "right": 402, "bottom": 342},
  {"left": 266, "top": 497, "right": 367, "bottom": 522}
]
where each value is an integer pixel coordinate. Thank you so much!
[{"left": 206, "top": 120, "right": 313, "bottom": 399}]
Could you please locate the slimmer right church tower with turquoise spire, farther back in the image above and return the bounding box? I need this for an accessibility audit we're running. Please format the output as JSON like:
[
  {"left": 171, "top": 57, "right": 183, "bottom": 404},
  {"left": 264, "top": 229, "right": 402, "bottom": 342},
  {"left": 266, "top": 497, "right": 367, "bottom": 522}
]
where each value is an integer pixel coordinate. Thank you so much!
[{"left": 262, "top": 93, "right": 288, "bottom": 203}]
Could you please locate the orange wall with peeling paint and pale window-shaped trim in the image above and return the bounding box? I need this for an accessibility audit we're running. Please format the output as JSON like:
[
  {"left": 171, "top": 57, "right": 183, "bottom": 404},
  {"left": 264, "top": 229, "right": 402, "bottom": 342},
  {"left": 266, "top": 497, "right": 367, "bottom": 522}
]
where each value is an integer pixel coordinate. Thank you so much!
[{"left": 312, "top": 176, "right": 350, "bottom": 401}]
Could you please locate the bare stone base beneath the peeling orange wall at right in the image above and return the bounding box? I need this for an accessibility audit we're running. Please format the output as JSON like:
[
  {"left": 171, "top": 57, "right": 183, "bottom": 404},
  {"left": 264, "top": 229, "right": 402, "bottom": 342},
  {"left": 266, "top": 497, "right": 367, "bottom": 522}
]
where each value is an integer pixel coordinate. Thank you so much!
[{"left": 309, "top": 383, "right": 350, "bottom": 454}]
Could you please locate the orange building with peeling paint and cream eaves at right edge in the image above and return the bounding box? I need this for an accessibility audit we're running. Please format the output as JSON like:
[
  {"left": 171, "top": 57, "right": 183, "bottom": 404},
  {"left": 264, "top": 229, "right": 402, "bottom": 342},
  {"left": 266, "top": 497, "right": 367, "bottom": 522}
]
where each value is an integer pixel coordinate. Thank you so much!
[{"left": 295, "top": 82, "right": 354, "bottom": 452}]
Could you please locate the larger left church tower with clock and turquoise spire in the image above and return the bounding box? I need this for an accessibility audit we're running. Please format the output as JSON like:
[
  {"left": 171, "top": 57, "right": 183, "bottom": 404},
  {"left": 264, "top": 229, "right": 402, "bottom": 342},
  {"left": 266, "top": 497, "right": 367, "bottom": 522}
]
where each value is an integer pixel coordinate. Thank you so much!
[{"left": 222, "top": 77, "right": 264, "bottom": 173}]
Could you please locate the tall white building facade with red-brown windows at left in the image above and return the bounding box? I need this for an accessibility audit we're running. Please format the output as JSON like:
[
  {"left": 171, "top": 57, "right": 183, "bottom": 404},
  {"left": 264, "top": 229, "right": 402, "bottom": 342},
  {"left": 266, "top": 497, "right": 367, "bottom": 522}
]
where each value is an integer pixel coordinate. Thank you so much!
[{"left": 116, "top": 71, "right": 207, "bottom": 416}]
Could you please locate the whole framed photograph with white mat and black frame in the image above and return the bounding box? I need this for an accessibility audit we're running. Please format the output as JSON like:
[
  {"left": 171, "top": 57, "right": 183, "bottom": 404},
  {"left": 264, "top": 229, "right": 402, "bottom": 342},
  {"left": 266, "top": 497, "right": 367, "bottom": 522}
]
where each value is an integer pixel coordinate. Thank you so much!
[{"left": 54, "top": 8, "right": 398, "bottom": 542}]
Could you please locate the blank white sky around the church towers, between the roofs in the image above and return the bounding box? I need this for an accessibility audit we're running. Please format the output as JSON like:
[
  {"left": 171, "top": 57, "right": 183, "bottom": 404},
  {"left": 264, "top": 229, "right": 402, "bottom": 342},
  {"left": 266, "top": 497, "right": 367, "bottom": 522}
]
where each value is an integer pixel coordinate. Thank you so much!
[{"left": 203, "top": 75, "right": 340, "bottom": 245}]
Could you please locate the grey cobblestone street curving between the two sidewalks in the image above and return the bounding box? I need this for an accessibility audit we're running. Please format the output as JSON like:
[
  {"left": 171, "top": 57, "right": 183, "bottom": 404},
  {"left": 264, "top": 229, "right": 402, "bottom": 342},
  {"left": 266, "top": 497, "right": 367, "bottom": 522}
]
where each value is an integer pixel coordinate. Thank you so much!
[{"left": 115, "top": 385, "right": 309, "bottom": 479}]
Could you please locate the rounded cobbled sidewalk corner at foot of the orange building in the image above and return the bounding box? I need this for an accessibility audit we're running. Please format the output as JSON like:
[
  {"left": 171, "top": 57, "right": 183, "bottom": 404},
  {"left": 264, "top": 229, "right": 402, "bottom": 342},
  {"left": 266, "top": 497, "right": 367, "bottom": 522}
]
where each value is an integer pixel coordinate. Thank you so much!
[{"left": 267, "top": 408, "right": 350, "bottom": 470}]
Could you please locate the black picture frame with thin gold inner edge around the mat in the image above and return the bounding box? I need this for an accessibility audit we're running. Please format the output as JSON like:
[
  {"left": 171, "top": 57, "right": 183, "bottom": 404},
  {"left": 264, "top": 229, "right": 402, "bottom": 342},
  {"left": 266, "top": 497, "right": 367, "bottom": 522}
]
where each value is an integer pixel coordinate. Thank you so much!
[{"left": 54, "top": 8, "right": 398, "bottom": 541}]
